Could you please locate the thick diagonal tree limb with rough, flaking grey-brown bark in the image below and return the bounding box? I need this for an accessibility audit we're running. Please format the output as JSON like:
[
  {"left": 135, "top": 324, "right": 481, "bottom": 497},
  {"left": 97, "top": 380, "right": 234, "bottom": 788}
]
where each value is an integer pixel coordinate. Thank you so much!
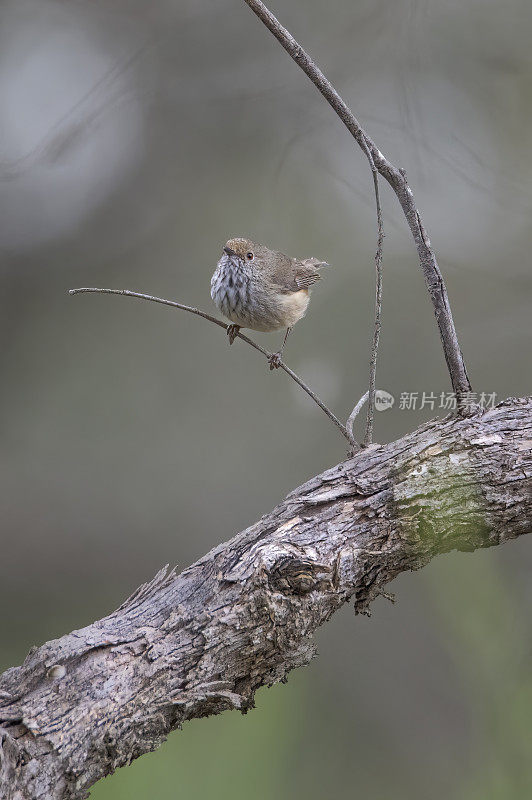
[{"left": 0, "top": 398, "right": 532, "bottom": 800}]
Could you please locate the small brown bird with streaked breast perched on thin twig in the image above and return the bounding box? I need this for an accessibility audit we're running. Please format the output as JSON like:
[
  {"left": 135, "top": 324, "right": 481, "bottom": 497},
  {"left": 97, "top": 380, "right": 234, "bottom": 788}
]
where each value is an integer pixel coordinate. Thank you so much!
[{"left": 211, "top": 234, "right": 328, "bottom": 369}]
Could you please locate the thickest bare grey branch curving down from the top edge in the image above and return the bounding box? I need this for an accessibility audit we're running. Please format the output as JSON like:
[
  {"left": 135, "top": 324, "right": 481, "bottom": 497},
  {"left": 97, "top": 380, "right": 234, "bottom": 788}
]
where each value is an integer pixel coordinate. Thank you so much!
[{"left": 245, "top": 0, "right": 471, "bottom": 406}]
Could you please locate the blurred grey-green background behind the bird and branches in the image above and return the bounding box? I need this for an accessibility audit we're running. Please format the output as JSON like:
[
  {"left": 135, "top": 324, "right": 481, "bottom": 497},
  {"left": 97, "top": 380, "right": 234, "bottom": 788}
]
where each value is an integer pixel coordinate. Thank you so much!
[{"left": 0, "top": 0, "right": 532, "bottom": 800}]
